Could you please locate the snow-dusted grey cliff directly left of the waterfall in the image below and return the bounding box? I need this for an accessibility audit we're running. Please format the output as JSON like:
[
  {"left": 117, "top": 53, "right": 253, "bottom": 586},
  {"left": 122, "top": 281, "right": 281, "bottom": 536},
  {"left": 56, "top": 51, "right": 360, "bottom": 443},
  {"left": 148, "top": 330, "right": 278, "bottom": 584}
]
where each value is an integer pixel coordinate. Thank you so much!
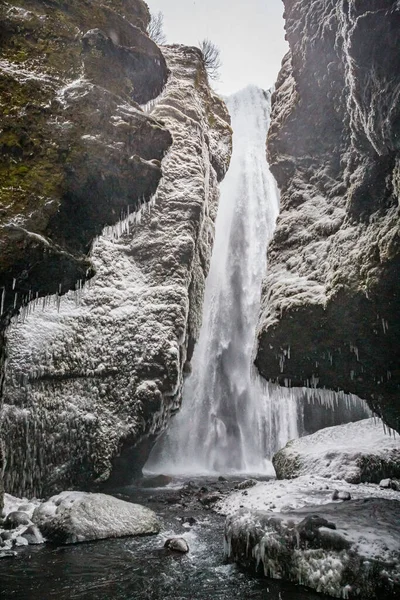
[{"left": 3, "top": 46, "right": 231, "bottom": 495}]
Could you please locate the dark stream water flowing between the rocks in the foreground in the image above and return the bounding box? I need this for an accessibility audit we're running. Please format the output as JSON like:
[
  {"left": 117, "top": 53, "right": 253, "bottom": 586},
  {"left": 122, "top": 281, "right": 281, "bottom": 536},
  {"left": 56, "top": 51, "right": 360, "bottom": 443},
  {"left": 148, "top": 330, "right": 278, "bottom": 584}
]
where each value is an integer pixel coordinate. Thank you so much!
[{"left": 0, "top": 480, "right": 332, "bottom": 600}]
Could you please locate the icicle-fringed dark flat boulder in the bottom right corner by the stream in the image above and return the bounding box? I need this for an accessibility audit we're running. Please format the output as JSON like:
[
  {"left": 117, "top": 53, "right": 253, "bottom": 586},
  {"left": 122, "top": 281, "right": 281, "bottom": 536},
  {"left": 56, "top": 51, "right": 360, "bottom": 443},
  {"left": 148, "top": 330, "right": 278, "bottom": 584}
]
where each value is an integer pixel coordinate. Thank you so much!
[{"left": 225, "top": 498, "right": 400, "bottom": 599}]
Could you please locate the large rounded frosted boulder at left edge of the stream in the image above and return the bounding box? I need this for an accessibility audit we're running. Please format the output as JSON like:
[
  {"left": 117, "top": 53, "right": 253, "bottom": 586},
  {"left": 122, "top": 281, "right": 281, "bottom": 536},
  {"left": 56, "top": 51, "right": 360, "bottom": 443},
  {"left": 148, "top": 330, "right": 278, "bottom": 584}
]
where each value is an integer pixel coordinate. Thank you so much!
[{"left": 33, "top": 492, "right": 160, "bottom": 544}]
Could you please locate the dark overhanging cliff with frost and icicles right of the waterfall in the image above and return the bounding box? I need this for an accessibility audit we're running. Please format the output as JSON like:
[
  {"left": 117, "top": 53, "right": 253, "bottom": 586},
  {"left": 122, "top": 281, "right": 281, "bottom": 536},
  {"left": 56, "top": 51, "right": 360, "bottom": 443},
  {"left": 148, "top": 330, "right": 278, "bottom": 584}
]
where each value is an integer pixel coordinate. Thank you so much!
[{"left": 256, "top": 0, "right": 400, "bottom": 430}]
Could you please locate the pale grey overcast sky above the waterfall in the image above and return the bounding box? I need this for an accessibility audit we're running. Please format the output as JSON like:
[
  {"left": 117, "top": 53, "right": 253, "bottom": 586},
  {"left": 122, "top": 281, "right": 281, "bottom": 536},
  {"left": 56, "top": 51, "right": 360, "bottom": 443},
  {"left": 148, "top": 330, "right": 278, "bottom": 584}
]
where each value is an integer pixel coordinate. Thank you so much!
[{"left": 147, "top": 0, "right": 288, "bottom": 95}]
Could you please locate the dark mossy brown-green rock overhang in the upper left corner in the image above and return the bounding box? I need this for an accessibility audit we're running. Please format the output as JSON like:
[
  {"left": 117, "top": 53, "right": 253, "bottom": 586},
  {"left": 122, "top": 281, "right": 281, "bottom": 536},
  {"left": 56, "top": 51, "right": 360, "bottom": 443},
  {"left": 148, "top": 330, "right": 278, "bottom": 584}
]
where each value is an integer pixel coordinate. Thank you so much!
[{"left": 0, "top": 0, "right": 172, "bottom": 505}]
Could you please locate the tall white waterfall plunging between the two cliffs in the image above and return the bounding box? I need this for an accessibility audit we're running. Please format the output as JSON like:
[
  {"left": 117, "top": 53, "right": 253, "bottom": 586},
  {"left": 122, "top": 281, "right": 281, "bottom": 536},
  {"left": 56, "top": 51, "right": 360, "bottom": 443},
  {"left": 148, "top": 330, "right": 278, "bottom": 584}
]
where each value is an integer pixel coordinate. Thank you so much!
[{"left": 147, "top": 86, "right": 297, "bottom": 474}]
